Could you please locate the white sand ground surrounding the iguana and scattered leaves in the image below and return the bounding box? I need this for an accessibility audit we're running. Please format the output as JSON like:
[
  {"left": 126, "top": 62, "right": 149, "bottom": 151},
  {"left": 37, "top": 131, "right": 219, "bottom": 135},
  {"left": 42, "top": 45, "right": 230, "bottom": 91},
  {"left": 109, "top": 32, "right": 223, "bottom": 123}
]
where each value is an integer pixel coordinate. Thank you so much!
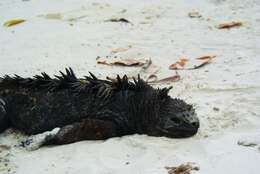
[{"left": 0, "top": 0, "right": 260, "bottom": 174}]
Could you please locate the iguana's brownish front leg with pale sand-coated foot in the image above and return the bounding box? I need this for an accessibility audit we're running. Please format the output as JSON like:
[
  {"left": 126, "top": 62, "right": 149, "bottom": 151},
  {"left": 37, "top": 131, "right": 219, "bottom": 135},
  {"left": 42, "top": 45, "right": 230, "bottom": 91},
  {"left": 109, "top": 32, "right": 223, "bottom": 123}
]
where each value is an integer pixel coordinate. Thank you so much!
[{"left": 22, "top": 119, "right": 117, "bottom": 150}]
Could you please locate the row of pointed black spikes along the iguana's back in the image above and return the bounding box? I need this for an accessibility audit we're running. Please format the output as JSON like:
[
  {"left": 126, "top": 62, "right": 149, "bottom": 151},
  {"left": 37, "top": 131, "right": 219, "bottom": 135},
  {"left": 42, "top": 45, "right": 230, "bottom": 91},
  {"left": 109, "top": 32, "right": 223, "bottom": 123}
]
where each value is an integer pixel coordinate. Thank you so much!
[{"left": 0, "top": 68, "right": 170, "bottom": 102}]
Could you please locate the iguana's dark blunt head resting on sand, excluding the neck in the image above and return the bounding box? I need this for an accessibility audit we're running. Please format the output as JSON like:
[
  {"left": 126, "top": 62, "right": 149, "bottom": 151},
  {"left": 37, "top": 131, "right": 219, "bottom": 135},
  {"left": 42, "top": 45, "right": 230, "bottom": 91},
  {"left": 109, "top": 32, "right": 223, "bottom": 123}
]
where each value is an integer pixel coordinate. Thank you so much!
[{"left": 144, "top": 88, "right": 199, "bottom": 138}]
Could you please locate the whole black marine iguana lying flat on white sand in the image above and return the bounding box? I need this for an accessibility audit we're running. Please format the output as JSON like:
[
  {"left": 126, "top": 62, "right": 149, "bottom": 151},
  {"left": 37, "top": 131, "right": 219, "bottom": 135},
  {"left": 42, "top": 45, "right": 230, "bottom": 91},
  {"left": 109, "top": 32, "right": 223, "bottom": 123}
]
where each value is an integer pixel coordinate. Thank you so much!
[{"left": 0, "top": 68, "right": 199, "bottom": 148}]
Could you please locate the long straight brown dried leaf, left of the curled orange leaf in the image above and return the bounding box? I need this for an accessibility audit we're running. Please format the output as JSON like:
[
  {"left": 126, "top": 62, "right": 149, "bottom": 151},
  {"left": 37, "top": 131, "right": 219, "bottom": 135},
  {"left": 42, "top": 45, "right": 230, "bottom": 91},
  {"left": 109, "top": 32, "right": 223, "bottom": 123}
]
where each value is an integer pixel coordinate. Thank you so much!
[{"left": 96, "top": 57, "right": 146, "bottom": 66}]
